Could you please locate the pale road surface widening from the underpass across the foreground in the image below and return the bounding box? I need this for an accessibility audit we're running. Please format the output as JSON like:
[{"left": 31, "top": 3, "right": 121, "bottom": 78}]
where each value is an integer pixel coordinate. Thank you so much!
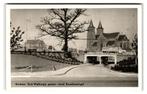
[{"left": 11, "top": 64, "right": 138, "bottom": 87}]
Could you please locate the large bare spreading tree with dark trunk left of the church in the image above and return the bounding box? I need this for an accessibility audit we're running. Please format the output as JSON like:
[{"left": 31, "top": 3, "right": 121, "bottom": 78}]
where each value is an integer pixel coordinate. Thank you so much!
[{"left": 37, "top": 8, "right": 86, "bottom": 56}]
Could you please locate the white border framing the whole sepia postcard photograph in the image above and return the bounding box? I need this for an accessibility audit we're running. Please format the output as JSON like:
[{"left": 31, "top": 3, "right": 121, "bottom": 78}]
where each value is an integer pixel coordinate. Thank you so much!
[{"left": 6, "top": 4, "right": 143, "bottom": 93}]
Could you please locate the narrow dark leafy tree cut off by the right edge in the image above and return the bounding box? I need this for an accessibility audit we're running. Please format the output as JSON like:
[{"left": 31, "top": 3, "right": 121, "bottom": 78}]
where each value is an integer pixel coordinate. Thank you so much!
[{"left": 132, "top": 34, "right": 138, "bottom": 64}]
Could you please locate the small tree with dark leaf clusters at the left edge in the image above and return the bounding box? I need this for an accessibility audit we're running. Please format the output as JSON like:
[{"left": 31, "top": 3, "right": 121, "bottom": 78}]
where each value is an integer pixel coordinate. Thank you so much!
[{"left": 10, "top": 25, "right": 24, "bottom": 51}]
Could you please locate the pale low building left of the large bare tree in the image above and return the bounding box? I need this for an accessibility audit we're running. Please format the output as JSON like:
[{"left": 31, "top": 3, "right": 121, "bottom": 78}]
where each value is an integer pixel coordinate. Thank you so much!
[{"left": 25, "top": 40, "right": 46, "bottom": 51}]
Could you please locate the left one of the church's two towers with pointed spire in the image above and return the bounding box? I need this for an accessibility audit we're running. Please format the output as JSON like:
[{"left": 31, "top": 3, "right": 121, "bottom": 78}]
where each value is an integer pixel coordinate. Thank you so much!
[{"left": 87, "top": 20, "right": 95, "bottom": 51}]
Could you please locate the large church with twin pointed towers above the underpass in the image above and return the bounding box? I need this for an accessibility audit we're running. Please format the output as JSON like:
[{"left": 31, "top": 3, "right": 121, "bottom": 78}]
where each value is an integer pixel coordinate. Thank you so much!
[{"left": 87, "top": 20, "right": 131, "bottom": 52}]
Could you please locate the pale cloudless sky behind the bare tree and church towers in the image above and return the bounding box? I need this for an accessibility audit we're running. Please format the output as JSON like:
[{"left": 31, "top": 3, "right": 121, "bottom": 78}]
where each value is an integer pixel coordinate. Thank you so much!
[{"left": 10, "top": 8, "right": 137, "bottom": 50}]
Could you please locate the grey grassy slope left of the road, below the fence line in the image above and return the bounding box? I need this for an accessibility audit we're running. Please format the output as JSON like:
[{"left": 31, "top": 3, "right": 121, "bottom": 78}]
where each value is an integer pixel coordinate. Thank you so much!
[{"left": 11, "top": 54, "right": 71, "bottom": 72}]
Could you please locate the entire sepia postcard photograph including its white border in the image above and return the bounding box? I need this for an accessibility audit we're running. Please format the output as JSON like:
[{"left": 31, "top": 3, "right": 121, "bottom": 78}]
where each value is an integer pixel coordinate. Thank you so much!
[{"left": 6, "top": 4, "right": 142, "bottom": 87}]
